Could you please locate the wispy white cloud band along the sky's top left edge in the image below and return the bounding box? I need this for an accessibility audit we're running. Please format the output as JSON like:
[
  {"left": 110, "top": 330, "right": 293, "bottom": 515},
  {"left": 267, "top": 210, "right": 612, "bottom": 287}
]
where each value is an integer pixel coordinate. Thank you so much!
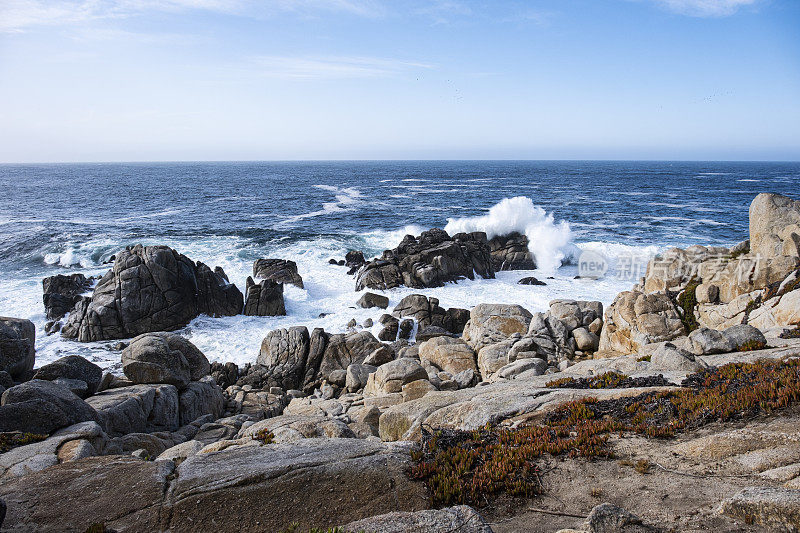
[{"left": 0, "top": 0, "right": 383, "bottom": 33}]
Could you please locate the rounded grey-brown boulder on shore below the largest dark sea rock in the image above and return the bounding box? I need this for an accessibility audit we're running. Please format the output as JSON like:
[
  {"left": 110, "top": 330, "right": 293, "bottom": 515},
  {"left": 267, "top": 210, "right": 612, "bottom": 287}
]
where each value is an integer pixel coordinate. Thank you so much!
[{"left": 122, "top": 333, "right": 211, "bottom": 389}]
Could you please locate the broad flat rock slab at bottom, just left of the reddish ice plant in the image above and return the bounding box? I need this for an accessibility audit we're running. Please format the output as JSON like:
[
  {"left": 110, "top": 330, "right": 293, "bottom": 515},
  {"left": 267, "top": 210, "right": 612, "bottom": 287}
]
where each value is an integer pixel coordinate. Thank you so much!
[{"left": 163, "top": 439, "right": 427, "bottom": 532}]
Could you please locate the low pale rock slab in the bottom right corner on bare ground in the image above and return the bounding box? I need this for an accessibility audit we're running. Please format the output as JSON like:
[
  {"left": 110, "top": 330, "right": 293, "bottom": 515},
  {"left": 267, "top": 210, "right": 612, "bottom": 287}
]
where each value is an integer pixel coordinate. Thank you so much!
[{"left": 720, "top": 487, "right": 800, "bottom": 532}]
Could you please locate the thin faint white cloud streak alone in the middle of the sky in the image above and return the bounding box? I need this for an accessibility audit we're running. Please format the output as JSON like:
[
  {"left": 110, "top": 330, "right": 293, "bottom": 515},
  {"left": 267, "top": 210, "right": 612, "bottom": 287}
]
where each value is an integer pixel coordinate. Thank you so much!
[{"left": 247, "top": 56, "right": 433, "bottom": 79}]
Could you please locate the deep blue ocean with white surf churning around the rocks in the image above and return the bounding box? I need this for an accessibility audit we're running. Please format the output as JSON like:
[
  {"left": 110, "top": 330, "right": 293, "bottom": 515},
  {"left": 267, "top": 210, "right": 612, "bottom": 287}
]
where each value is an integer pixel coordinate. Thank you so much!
[{"left": 0, "top": 161, "right": 800, "bottom": 370}]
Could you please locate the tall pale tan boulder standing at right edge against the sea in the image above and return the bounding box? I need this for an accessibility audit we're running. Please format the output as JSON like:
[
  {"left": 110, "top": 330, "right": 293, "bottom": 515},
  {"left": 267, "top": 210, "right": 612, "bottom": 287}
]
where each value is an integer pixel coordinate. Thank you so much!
[{"left": 750, "top": 193, "right": 800, "bottom": 260}]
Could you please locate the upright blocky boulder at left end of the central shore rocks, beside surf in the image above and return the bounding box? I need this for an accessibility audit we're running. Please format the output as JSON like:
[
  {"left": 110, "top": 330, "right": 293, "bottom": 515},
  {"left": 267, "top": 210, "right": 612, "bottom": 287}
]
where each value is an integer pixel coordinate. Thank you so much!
[{"left": 257, "top": 326, "right": 311, "bottom": 390}]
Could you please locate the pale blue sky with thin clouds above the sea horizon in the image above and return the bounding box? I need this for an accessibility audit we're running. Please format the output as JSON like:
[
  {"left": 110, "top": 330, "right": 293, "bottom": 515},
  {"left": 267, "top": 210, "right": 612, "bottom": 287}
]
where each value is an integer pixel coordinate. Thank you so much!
[{"left": 0, "top": 0, "right": 800, "bottom": 162}]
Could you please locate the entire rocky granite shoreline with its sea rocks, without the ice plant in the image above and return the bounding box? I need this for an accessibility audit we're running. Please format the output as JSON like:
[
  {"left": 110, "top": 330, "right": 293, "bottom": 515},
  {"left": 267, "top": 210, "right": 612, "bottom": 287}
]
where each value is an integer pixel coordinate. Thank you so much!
[{"left": 0, "top": 194, "right": 800, "bottom": 532}]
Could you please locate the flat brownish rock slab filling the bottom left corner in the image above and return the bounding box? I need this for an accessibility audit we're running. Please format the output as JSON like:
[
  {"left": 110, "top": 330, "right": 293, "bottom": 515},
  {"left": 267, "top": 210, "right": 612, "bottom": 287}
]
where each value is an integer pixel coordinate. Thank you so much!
[{"left": 0, "top": 455, "right": 174, "bottom": 533}]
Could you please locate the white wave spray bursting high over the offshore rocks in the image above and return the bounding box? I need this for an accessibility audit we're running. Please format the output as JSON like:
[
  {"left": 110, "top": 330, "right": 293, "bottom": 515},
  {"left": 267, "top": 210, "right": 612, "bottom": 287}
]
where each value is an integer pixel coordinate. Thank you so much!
[{"left": 444, "top": 196, "right": 572, "bottom": 275}]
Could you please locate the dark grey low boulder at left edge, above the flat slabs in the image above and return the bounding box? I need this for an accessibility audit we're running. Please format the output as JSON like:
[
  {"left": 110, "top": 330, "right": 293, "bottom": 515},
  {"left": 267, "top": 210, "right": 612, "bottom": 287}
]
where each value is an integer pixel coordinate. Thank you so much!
[{"left": 0, "top": 379, "right": 102, "bottom": 435}]
